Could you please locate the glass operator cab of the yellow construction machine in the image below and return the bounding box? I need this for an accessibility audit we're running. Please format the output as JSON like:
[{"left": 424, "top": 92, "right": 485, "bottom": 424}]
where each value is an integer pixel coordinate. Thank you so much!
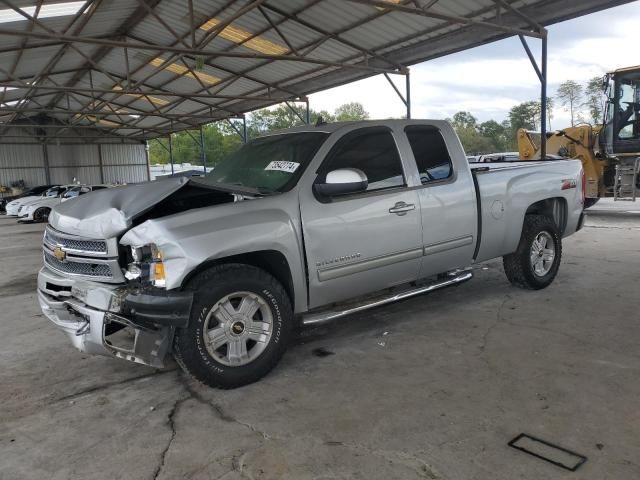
[{"left": 600, "top": 66, "right": 640, "bottom": 156}]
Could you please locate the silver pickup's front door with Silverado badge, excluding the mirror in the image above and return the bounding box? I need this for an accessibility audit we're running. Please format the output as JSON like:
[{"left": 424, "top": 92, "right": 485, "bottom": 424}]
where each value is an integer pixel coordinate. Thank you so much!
[{"left": 300, "top": 127, "right": 422, "bottom": 308}]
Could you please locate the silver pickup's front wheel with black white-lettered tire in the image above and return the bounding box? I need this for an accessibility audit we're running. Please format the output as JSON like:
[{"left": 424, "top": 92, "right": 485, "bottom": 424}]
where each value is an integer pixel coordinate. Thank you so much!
[{"left": 173, "top": 264, "right": 294, "bottom": 389}]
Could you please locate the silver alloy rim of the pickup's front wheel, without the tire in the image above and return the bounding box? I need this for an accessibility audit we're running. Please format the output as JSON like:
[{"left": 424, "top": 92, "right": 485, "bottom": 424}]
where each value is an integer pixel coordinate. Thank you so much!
[{"left": 203, "top": 292, "right": 273, "bottom": 367}]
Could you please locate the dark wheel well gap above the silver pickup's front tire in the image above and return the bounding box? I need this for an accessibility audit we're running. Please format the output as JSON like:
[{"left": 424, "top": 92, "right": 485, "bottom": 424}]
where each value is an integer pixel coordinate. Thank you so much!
[{"left": 182, "top": 250, "right": 295, "bottom": 305}]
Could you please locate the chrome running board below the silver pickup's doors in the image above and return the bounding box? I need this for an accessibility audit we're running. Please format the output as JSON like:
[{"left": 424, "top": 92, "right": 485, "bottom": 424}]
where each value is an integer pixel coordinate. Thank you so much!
[{"left": 302, "top": 270, "right": 473, "bottom": 325}]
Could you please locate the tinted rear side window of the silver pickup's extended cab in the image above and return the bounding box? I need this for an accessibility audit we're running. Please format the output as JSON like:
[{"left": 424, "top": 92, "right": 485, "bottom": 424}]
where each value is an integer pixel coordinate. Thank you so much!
[{"left": 405, "top": 125, "right": 453, "bottom": 185}]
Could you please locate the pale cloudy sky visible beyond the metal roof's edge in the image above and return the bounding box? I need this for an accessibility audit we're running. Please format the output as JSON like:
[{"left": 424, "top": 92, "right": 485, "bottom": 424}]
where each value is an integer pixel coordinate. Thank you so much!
[{"left": 309, "top": 1, "right": 640, "bottom": 128}]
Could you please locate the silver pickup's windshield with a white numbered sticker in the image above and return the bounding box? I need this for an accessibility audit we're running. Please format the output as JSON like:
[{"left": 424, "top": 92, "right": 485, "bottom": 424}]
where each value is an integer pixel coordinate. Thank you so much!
[{"left": 204, "top": 132, "right": 329, "bottom": 193}]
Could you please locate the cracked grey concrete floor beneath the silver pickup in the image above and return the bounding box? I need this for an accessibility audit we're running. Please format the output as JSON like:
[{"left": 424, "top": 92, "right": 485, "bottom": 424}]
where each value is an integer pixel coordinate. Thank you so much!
[{"left": 0, "top": 202, "right": 640, "bottom": 480}]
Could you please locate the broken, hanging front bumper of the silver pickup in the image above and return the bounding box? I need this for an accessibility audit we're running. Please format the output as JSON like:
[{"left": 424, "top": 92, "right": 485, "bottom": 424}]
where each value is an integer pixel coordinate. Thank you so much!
[{"left": 38, "top": 267, "right": 193, "bottom": 368}]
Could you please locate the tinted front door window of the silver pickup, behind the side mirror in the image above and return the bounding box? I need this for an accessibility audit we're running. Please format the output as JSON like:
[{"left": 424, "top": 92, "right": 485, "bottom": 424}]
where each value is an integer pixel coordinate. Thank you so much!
[{"left": 321, "top": 128, "right": 405, "bottom": 192}]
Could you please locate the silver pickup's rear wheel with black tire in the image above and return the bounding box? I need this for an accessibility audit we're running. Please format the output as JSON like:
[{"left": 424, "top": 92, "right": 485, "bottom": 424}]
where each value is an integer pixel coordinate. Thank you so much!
[{"left": 502, "top": 215, "right": 562, "bottom": 290}]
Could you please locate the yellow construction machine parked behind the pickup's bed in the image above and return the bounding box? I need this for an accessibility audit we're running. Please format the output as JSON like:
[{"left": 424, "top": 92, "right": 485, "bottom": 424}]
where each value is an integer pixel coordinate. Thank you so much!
[{"left": 517, "top": 66, "right": 640, "bottom": 208}]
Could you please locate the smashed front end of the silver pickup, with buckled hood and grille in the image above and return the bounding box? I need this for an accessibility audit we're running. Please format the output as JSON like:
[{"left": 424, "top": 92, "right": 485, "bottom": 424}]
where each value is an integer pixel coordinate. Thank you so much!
[{"left": 38, "top": 179, "right": 260, "bottom": 367}]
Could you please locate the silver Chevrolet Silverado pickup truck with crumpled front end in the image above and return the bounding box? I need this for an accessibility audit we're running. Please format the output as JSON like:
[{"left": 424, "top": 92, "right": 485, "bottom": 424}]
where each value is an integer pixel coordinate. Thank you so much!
[{"left": 38, "top": 120, "right": 584, "bottom": 388}]
